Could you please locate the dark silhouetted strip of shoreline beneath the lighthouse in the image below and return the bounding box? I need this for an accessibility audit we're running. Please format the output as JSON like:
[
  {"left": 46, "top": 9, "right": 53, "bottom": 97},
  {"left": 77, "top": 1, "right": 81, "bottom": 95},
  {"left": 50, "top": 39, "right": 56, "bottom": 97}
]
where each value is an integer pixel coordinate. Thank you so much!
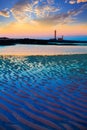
[{"left": 0, "top": 37, "right": 87, "bottom": 46}]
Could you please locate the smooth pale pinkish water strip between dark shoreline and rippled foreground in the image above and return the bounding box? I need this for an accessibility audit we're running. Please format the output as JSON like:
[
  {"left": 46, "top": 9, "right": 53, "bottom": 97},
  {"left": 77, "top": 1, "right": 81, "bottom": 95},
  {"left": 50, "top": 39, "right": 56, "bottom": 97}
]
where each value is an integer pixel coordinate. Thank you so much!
[{"left": 0, "top": 45, "right": 87, "bottom": 56}]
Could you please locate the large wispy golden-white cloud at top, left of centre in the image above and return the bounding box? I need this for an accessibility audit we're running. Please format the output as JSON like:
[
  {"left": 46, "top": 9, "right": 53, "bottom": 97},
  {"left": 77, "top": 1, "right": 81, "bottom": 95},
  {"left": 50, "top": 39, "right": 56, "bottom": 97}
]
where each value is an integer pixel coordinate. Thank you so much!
[{"left": 11, "top": 0, "right": 59, "bottom": 21}]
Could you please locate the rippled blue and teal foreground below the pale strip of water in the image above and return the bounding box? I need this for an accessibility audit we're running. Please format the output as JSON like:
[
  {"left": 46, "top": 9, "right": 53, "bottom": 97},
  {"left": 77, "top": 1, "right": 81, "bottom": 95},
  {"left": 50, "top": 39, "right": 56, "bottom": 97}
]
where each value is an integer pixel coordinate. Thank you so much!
[{"left": 0, "top": 54, "right": 87, "bottom": 130}]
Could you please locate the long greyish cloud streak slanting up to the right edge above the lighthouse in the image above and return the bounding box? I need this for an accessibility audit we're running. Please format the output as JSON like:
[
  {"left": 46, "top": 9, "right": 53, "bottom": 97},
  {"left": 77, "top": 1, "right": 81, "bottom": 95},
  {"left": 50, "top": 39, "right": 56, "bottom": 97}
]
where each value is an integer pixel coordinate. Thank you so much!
[{"left": 36, "top": 5, "right": 87, "bottom": 25}]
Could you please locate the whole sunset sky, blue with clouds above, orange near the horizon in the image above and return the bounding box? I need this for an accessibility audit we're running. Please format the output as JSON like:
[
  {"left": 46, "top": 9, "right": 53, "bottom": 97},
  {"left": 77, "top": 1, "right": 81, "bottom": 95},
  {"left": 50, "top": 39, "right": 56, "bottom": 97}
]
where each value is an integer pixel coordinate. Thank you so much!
[{"left": 0, "top": 0, "right": 87, "bottom": 38}]
